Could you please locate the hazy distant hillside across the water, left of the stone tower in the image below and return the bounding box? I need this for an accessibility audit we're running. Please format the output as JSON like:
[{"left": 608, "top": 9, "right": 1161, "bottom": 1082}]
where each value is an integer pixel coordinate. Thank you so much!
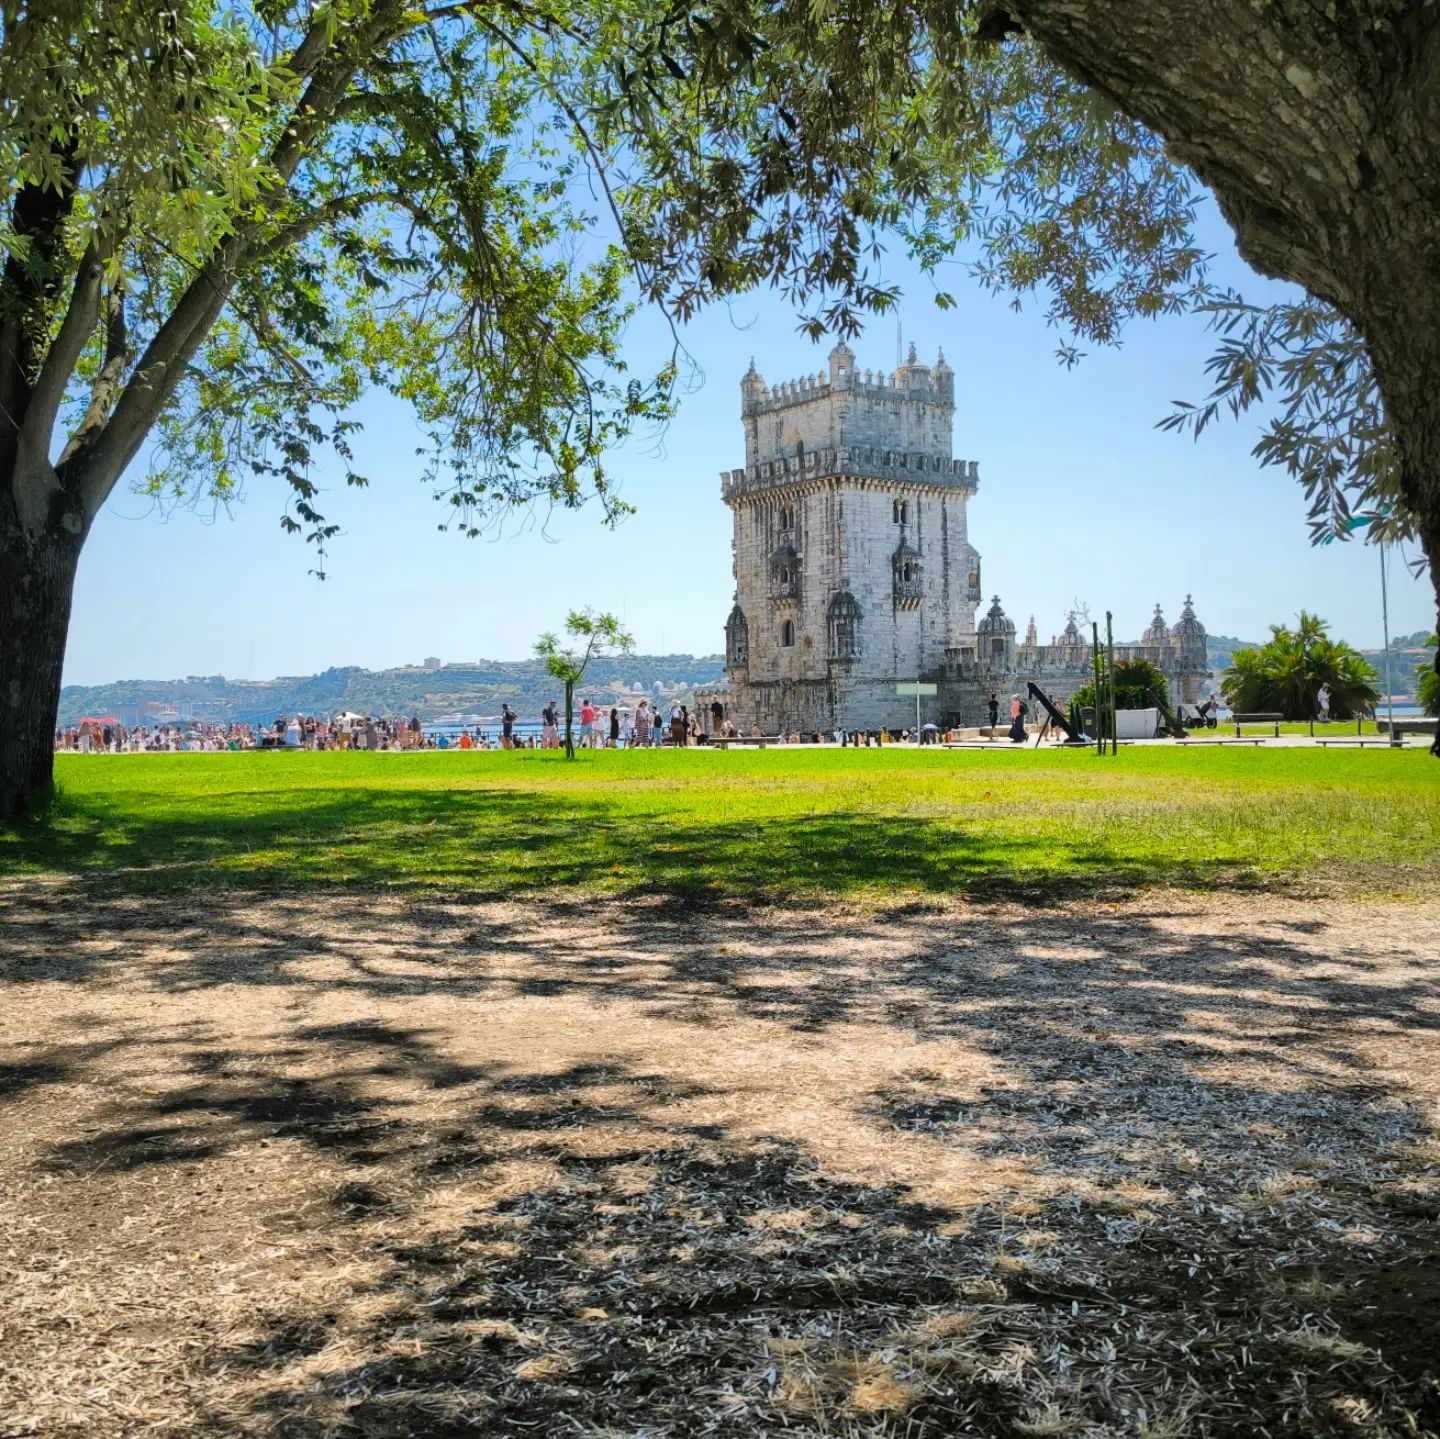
[{"left": 60, "top": 654, "right": 724, "bottom": 725}]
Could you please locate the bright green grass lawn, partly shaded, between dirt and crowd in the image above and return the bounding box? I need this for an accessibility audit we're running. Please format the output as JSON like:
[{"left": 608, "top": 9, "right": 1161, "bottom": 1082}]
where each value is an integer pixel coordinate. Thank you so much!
[{"left": 0, "top": 748, "right": 1440, "bottom": 899}]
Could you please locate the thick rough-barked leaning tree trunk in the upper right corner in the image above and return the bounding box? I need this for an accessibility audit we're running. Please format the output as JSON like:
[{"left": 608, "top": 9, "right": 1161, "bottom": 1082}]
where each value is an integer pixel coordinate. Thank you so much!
[{"left": 979, "top": 0, "right": 1440, "bottom": 755}]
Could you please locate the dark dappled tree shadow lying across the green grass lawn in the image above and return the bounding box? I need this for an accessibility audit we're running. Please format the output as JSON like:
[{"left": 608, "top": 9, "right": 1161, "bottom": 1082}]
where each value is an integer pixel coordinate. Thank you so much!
[{"left": 0, "top": 786, "right": 1276, "bottom": 906}]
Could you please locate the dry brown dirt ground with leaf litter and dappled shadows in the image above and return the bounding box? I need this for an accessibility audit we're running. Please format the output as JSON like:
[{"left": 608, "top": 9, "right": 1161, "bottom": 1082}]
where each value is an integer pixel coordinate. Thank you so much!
[{"left": 0, "top": 883, "right": 1440, "bottom": 1439}]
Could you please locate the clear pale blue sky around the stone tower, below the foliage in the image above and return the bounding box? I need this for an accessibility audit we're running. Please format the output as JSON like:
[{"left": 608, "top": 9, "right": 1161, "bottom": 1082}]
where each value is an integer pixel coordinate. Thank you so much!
[{"left": 65, "top": 212, "right": 1434, "bottom": 684}]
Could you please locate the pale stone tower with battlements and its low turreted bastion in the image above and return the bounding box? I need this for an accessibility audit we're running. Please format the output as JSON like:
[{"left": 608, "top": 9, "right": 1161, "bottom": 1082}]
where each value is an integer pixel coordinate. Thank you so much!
[{"left": 708, "top": 344, "right": 1208, "bottom": 735}]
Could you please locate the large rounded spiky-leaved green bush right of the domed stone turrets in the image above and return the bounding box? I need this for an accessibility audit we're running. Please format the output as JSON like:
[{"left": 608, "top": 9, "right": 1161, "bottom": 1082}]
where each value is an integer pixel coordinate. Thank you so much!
[{"left": 1220, "top": 609, "right": 1380, "bottom": 720}]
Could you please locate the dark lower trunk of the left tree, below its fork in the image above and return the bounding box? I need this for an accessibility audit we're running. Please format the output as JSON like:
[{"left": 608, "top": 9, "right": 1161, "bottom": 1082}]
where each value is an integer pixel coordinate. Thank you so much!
[{"left": 0, "top": 501, "right": 85, "bottom": 821}]
